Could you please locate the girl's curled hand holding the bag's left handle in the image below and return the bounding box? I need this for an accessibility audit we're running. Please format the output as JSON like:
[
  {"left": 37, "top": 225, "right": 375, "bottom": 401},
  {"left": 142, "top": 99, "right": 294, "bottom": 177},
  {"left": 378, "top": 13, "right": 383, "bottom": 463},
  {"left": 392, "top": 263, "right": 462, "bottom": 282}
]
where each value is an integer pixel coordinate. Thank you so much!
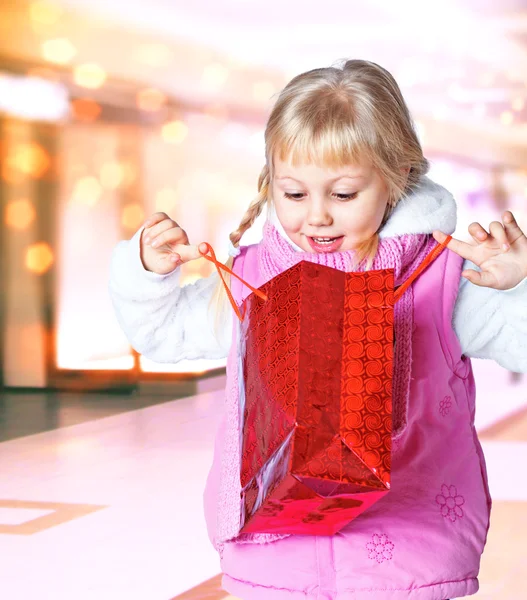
[{"left": 141, "top": 212, "right": 207, "bottom": 275}]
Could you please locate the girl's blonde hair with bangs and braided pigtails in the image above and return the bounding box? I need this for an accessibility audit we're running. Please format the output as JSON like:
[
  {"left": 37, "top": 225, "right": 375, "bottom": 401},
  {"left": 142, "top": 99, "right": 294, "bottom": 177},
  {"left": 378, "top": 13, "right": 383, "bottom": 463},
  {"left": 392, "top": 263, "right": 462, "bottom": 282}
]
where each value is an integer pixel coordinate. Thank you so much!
[{"left": 206, "top": 60, "right": 429, "bottom": 322}]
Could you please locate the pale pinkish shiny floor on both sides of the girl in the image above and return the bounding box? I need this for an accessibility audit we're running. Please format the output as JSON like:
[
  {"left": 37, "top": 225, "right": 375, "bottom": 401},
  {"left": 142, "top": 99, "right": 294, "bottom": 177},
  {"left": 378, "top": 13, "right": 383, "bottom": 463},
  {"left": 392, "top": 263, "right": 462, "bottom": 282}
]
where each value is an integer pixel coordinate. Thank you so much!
[{"left": 0, "top": 361, "right": 527, "bottom": 600}]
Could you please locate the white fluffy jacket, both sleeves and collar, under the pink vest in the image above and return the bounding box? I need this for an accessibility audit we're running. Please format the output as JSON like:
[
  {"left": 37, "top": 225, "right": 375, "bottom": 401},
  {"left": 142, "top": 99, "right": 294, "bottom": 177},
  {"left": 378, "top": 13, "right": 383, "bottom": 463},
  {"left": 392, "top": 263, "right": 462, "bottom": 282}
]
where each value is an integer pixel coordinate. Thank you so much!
[{"left": 109, "top": 177, "right": 527, "bottom": 373}]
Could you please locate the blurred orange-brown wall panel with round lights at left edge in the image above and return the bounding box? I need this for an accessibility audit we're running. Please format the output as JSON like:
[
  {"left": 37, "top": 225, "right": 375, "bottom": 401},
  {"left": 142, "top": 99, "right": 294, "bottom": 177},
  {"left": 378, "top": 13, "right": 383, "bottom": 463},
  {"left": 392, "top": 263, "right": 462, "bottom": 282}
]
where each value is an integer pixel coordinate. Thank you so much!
[{"left": 0, "top": 118, "right": 57, "bottom": 388}]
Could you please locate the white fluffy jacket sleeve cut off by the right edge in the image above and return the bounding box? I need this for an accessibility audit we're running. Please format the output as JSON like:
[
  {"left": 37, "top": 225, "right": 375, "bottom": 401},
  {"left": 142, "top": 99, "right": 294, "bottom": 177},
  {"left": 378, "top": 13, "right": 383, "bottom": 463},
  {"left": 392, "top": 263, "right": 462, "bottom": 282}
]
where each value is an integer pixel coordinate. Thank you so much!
[{"left": 453, "top": 260, "right": 527, "bottom": 373}]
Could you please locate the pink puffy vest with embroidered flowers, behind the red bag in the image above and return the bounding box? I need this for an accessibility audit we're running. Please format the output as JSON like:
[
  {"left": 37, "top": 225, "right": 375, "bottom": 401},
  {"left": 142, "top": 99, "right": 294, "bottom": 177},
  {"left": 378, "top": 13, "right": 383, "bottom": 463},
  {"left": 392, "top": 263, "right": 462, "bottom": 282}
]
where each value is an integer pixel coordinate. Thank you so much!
[{"left": 204, "top": 245, "right": 491, "bottom": 600}]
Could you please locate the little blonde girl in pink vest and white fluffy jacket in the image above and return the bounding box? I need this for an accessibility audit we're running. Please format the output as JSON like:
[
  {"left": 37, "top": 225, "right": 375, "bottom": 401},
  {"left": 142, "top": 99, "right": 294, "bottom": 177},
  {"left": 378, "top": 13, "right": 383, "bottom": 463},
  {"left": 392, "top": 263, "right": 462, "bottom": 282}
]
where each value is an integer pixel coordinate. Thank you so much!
[{"left": 110, "top": 60, "right": 527, "bottom": 600}]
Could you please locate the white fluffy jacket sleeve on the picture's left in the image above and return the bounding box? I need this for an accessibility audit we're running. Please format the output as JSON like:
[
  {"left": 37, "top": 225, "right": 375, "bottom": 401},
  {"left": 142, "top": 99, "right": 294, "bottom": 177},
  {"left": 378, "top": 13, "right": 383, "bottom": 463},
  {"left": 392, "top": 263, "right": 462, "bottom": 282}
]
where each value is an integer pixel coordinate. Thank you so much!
[{"left": 109, "top": 228, "right": 231, "bottom": 363}]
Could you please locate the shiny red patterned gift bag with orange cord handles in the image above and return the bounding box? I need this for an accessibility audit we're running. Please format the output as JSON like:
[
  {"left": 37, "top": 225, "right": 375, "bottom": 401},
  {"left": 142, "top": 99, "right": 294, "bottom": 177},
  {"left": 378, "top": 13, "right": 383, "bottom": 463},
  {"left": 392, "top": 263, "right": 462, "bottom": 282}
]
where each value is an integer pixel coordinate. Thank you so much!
[{"left": 202, "top": 236, "right": 452, "bottom": 535}]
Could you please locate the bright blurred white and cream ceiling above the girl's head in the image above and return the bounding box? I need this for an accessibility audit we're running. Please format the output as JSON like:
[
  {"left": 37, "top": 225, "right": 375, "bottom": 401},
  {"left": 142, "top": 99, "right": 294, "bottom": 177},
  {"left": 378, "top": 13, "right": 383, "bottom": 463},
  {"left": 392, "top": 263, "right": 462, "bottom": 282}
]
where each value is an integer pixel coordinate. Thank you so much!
[{"left": 0, "top": 0, "right": 527, "bottom": 166}]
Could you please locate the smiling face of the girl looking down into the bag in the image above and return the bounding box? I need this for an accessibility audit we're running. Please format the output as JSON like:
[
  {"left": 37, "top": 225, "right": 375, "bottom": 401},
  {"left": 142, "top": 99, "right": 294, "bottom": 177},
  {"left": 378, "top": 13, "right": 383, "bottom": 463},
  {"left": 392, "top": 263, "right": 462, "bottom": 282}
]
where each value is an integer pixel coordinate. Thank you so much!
[{"left": 272, "top": 159, "right": 389, "bottom": 252}]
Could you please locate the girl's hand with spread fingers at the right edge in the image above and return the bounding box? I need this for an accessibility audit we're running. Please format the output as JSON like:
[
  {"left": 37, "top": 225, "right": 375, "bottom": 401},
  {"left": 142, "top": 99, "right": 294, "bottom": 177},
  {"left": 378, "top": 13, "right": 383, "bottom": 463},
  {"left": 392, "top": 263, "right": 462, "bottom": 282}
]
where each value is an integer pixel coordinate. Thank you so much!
[{"left": 433, "top": 210, "right": 527, "bottom": 290}]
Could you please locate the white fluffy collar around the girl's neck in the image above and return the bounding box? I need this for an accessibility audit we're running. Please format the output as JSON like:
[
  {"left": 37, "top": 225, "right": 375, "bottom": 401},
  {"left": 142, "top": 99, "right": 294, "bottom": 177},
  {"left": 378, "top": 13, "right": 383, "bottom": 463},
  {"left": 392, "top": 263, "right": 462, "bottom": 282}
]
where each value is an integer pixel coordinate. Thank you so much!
[{"left": 268, "top": 176, "right": 457, "bottom": 251}]
